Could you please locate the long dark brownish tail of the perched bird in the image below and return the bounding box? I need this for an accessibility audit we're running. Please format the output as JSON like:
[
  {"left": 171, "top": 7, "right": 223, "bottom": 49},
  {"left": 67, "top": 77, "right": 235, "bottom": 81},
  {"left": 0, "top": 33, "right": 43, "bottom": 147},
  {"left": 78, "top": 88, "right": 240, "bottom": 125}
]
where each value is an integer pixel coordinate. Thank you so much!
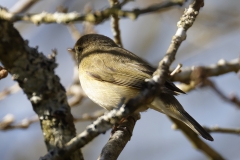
[{"left": 151, "top": 93, "right": 213, "bottom": 141}]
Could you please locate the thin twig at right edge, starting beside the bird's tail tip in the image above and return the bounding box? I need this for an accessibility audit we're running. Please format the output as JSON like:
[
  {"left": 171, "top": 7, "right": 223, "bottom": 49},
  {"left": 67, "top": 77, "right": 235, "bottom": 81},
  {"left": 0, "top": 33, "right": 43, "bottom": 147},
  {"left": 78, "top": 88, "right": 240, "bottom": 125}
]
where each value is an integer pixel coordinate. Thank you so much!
[{"left": 204, "top": 126, "right": 240, "bottom": 135}]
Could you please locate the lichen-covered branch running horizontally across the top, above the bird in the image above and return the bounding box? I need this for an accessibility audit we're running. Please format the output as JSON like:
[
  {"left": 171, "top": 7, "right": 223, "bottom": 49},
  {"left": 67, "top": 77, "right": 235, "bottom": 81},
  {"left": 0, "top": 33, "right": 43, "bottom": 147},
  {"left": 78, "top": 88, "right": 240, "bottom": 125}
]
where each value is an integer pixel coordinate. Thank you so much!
[{"left": 0, "top": 0, "right": 185, "bottom": 25}]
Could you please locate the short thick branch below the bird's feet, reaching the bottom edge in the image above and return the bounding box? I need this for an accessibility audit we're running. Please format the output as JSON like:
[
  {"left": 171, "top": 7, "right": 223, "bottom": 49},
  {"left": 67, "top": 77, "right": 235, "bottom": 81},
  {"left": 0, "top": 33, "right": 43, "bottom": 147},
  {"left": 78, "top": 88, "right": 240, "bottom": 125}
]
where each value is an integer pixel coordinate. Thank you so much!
[{"left": 98, "top": 114, "right": 140, "bottom": 160}]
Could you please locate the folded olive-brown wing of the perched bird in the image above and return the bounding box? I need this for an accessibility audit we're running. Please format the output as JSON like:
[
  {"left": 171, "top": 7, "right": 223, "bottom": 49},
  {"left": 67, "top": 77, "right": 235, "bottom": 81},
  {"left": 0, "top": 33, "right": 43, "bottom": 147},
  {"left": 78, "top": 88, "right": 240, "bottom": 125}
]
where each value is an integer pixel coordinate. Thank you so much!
[{"left": 83, "top": 47, "right": 154, "bottom": 89}]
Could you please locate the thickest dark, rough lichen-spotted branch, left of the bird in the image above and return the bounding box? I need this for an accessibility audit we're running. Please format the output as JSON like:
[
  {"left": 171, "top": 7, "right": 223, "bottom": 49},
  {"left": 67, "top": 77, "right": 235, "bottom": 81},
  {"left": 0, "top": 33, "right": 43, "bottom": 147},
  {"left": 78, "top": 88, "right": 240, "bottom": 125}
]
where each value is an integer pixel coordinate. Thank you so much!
[{"left": 0, "top": 20, "right": 83, "bottom": 159}]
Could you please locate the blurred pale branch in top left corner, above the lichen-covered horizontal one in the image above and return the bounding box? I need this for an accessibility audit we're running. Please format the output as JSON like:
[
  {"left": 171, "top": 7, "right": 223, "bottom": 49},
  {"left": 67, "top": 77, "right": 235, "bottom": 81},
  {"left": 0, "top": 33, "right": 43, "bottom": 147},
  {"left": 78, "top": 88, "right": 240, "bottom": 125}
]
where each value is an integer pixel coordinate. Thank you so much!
[{"left": 10, "top": 0, "right": 39, "bottom": 14}]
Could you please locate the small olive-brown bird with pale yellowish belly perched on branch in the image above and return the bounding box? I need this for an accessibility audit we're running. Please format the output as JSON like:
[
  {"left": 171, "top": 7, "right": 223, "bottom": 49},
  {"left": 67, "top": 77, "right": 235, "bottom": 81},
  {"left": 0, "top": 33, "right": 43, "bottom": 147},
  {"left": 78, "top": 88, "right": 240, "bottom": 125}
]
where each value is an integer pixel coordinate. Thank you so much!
[{"left": 69, "top": 34, "right": 213, "bottom": 141}]
